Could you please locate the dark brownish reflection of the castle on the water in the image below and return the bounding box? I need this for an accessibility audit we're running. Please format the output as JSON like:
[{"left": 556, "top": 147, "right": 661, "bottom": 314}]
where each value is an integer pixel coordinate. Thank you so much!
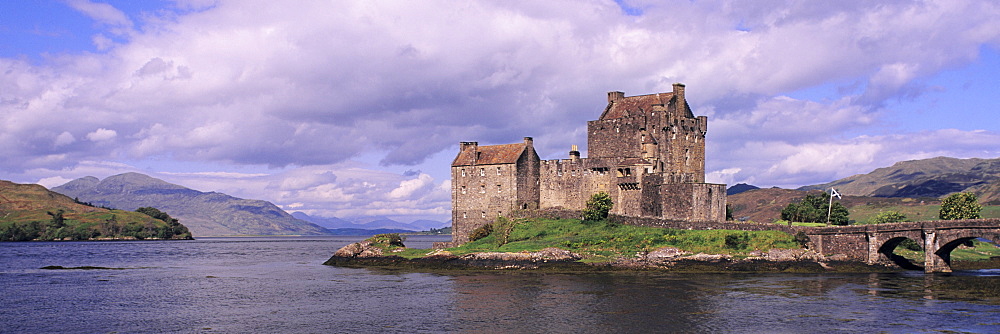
[{"left": 454, "top": 273, "right": 715, "bottom": 332}]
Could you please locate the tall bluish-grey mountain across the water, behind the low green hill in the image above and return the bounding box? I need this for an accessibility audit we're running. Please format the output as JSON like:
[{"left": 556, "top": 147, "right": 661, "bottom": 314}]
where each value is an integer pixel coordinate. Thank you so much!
[{"left": 52, "top": 173, "right": 329, "bottom": 237}]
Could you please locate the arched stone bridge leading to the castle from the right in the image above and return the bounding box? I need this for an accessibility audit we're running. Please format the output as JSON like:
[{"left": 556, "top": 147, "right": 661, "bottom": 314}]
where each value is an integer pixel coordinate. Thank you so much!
[{"left": 800, "top": 219, "right": 1000, "bottom": 272}]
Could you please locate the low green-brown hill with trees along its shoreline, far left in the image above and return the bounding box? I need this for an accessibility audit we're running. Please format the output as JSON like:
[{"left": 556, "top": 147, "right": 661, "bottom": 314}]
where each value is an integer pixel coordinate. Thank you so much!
[{"left": 0, "top": 180, "right": 190, "bottom": 241}]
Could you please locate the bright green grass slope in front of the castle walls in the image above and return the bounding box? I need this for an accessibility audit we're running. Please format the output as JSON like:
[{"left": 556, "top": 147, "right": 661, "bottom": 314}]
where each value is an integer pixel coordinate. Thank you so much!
[{"left": 394, "top": 219, "right": 799, "bottom": 262}]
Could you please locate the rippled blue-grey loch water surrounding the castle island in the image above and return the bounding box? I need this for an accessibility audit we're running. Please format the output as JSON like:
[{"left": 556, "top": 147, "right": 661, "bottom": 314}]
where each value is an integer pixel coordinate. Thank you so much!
[{"left": 0, "top": 236, "right": 1000, "bottom": 333}]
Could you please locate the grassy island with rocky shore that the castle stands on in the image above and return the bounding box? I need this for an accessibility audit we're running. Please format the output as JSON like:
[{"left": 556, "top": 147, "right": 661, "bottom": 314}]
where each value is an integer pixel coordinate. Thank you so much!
[{"left": 325, "top": 217, "right": 1000, "bottom": 272}]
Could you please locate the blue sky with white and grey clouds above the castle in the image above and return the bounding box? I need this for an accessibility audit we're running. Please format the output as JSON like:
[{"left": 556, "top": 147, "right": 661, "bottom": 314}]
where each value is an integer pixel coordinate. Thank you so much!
[{"left": 0, "top": 0, "right": 1000, "bottom": 222}]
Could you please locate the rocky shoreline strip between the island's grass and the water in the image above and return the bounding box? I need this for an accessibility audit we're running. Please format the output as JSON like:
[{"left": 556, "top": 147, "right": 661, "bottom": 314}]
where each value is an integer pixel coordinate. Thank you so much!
[{"left": 323, "top": 241, "right": 900, "bottom": 273}]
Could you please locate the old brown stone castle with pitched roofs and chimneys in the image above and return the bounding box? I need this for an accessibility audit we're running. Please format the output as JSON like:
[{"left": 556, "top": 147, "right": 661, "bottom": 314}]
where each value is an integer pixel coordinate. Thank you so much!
[{"left": 451, "top": 84, "right": 726, "bottom": 244}]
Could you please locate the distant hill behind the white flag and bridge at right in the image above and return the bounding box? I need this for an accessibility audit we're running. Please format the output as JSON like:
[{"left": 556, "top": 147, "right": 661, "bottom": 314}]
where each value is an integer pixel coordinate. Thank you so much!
[{"left": 799, "top": 157, "right": 1000, "bottom": 204}]
